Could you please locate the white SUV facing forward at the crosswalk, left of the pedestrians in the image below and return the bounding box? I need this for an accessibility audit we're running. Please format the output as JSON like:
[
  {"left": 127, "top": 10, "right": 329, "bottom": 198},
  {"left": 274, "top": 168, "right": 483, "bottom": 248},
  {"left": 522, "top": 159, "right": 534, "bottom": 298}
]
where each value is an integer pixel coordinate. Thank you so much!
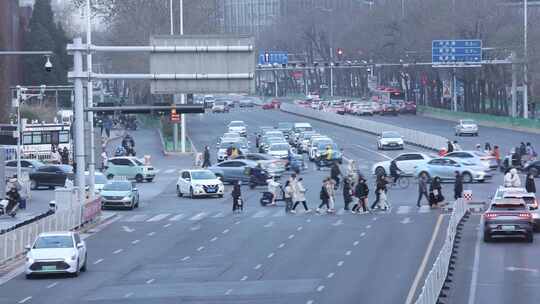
[{"left": 176, "top": 170, "right": 225, "bottom": 198}]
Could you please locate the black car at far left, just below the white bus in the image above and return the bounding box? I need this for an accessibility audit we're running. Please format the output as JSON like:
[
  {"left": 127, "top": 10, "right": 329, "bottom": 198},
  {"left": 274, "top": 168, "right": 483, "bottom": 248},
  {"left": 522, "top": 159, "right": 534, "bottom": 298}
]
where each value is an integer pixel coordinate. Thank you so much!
[{"left": 30, "top": 165, "right": 73, "bottom": 189}]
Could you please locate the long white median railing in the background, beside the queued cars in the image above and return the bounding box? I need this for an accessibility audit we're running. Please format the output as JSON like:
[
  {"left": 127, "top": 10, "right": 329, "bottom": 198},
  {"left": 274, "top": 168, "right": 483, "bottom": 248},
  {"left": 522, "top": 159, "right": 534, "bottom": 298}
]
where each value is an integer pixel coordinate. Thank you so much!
[{"left": 281, "top": 103, "right": 448, "bottom": 151}]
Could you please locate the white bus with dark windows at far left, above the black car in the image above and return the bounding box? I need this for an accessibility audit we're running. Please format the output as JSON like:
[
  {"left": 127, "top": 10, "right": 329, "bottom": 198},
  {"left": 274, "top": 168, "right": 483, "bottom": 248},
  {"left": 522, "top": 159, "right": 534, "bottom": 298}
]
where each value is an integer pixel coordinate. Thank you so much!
[{"left": 0, "top": 123, "right": 72, "bottom": 161}]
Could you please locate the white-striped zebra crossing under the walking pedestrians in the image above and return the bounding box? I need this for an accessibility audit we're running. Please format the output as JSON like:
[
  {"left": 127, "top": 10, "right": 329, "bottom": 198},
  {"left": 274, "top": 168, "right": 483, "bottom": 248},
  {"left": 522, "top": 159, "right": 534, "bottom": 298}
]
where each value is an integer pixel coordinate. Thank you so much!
[{"left": 119, "top": 206, "right": 438, "bottom": 223}]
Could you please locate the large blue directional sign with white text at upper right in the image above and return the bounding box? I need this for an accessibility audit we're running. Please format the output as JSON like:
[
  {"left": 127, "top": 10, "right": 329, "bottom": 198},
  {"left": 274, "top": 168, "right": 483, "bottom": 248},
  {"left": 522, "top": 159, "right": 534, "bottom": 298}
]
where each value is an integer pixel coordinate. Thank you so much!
[{"left": 431, "top": 39, "right": 482, "bottom": 65}]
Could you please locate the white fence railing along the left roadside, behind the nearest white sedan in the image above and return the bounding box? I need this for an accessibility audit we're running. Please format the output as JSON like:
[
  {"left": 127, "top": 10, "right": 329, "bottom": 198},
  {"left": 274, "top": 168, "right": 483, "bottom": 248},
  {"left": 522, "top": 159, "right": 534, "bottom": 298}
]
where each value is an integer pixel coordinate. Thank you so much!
[{"left": 0, "top": 199, "right": 101, "bottom": 265}]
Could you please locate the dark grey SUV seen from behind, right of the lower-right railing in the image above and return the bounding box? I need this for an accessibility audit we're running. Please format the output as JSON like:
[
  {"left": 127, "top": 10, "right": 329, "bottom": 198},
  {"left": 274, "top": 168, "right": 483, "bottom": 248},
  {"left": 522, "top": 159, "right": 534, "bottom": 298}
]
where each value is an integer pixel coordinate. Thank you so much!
[{"left": 484, "top": 198, "right": 534, "bottom": 243}]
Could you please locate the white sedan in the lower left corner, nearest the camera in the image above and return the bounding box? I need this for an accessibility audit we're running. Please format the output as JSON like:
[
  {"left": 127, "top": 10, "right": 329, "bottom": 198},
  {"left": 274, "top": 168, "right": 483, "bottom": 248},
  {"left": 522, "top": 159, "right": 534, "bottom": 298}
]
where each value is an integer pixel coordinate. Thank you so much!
[{"left": 25, "top": 231, "right": 87, "bottom": 279}]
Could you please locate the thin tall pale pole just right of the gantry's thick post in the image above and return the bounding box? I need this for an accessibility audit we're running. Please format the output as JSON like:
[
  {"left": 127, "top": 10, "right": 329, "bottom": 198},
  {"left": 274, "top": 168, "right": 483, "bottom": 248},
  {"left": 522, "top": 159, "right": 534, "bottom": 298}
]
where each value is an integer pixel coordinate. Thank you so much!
[{"left": 86, "top": 0, "right": 96, "bottom": 198}]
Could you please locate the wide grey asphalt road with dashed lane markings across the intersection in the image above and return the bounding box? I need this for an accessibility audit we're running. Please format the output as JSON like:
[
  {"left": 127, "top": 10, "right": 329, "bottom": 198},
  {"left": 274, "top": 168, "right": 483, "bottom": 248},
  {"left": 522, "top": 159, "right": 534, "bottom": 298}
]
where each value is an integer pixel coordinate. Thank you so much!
[{"left": 0, "top": 109, "right": 536, "bottom": 304}]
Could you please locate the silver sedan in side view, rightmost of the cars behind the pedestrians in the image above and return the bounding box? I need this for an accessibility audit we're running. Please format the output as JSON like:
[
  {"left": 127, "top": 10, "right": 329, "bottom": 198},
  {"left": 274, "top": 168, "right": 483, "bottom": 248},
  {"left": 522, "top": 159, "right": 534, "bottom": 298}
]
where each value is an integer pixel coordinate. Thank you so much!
[{"left": 414, "top": 158, "right": 491, "bottom": 183}]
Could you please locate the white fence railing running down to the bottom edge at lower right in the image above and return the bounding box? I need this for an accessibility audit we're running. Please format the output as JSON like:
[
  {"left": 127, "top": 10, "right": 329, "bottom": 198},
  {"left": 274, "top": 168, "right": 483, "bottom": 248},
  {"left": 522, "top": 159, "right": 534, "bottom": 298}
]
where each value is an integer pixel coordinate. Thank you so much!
[{"left": 415, "top": 199, "right": 467, "bottom": 304}]
